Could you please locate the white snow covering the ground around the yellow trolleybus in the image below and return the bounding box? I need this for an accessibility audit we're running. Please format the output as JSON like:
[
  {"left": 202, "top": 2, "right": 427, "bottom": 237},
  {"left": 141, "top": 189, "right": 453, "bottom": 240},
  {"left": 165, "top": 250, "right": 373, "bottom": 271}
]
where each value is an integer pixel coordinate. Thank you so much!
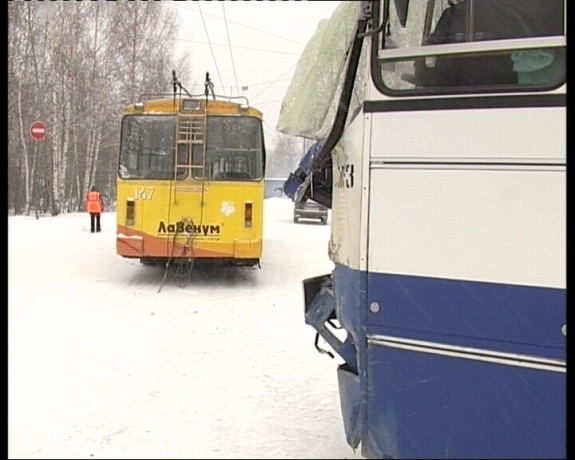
[{"left": 8, "top": 198, "right": 361, "bottom": 459}]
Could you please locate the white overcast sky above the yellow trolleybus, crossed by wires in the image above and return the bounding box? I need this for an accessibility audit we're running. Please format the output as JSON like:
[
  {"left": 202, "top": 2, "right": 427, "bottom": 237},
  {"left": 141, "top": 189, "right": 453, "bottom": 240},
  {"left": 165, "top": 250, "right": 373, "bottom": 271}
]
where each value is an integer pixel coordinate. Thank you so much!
[{"left": 166, "top": 0, "right": 339, "bottom": 146}]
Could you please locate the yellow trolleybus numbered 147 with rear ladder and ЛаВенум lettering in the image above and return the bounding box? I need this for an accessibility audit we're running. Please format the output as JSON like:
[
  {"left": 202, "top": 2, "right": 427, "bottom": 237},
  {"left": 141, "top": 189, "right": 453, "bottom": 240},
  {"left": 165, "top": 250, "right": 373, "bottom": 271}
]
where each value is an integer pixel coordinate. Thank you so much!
[{"left": 116, "top": 77, "right": 266, "bottom": 267}]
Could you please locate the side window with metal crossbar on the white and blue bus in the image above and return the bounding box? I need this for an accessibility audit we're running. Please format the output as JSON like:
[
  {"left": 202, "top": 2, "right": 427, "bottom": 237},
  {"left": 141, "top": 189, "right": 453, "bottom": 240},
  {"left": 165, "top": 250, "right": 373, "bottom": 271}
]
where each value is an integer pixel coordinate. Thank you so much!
[{"left": 372, "top": 0, "right": 566, "bottom": 93}]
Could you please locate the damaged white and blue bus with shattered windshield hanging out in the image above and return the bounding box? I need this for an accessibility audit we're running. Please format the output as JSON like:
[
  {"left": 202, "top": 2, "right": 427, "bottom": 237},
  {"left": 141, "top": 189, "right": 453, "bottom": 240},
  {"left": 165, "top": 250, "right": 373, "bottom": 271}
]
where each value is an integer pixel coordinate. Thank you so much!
[{"left": 278, "top": 0, "right": 567, "bottom": 459}]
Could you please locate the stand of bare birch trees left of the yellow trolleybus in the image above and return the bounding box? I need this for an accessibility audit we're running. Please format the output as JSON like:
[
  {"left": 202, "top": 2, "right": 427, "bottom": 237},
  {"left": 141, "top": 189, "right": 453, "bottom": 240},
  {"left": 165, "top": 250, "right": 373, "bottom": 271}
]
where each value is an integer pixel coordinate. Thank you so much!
[{"left": 8, "top": 1, "right": 189, "bottom": 215}]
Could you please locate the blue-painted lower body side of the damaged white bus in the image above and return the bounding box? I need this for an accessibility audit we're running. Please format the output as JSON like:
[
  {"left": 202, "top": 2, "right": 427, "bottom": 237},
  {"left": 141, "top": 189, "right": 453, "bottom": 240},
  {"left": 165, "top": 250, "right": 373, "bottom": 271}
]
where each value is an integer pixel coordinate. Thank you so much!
[{"left": 333, "top": 264, "right": 566, "bottom": 458}]
